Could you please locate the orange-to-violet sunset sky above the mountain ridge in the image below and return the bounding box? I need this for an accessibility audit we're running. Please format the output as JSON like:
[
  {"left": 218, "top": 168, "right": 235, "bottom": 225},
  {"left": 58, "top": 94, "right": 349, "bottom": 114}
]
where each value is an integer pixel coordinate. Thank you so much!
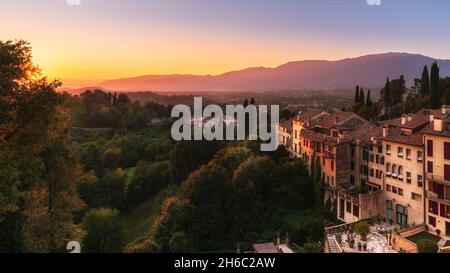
[{"left": 0, "top": 0, "right": 450, "bottom": 86}]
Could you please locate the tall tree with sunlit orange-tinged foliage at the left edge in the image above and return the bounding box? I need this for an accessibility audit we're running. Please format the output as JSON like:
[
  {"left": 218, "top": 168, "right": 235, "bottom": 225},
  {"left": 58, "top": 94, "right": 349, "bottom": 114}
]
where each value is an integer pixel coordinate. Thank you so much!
[{"left": 0, "top": 41, "right": 83, "bottom": 252}]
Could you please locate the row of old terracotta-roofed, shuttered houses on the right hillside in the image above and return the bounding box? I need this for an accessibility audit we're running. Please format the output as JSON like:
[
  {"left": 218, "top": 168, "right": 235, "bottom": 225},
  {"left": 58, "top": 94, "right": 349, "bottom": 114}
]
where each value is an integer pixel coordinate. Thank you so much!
[{"left": 280, "top": 106, "right": 450, "bottom": 252}]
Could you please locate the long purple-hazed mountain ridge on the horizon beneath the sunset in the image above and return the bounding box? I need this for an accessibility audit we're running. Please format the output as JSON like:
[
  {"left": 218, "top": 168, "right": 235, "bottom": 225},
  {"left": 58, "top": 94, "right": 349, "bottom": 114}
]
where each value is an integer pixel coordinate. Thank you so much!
[{"left": 89, "top": 53, "right": 450, "bottom": 92}]
